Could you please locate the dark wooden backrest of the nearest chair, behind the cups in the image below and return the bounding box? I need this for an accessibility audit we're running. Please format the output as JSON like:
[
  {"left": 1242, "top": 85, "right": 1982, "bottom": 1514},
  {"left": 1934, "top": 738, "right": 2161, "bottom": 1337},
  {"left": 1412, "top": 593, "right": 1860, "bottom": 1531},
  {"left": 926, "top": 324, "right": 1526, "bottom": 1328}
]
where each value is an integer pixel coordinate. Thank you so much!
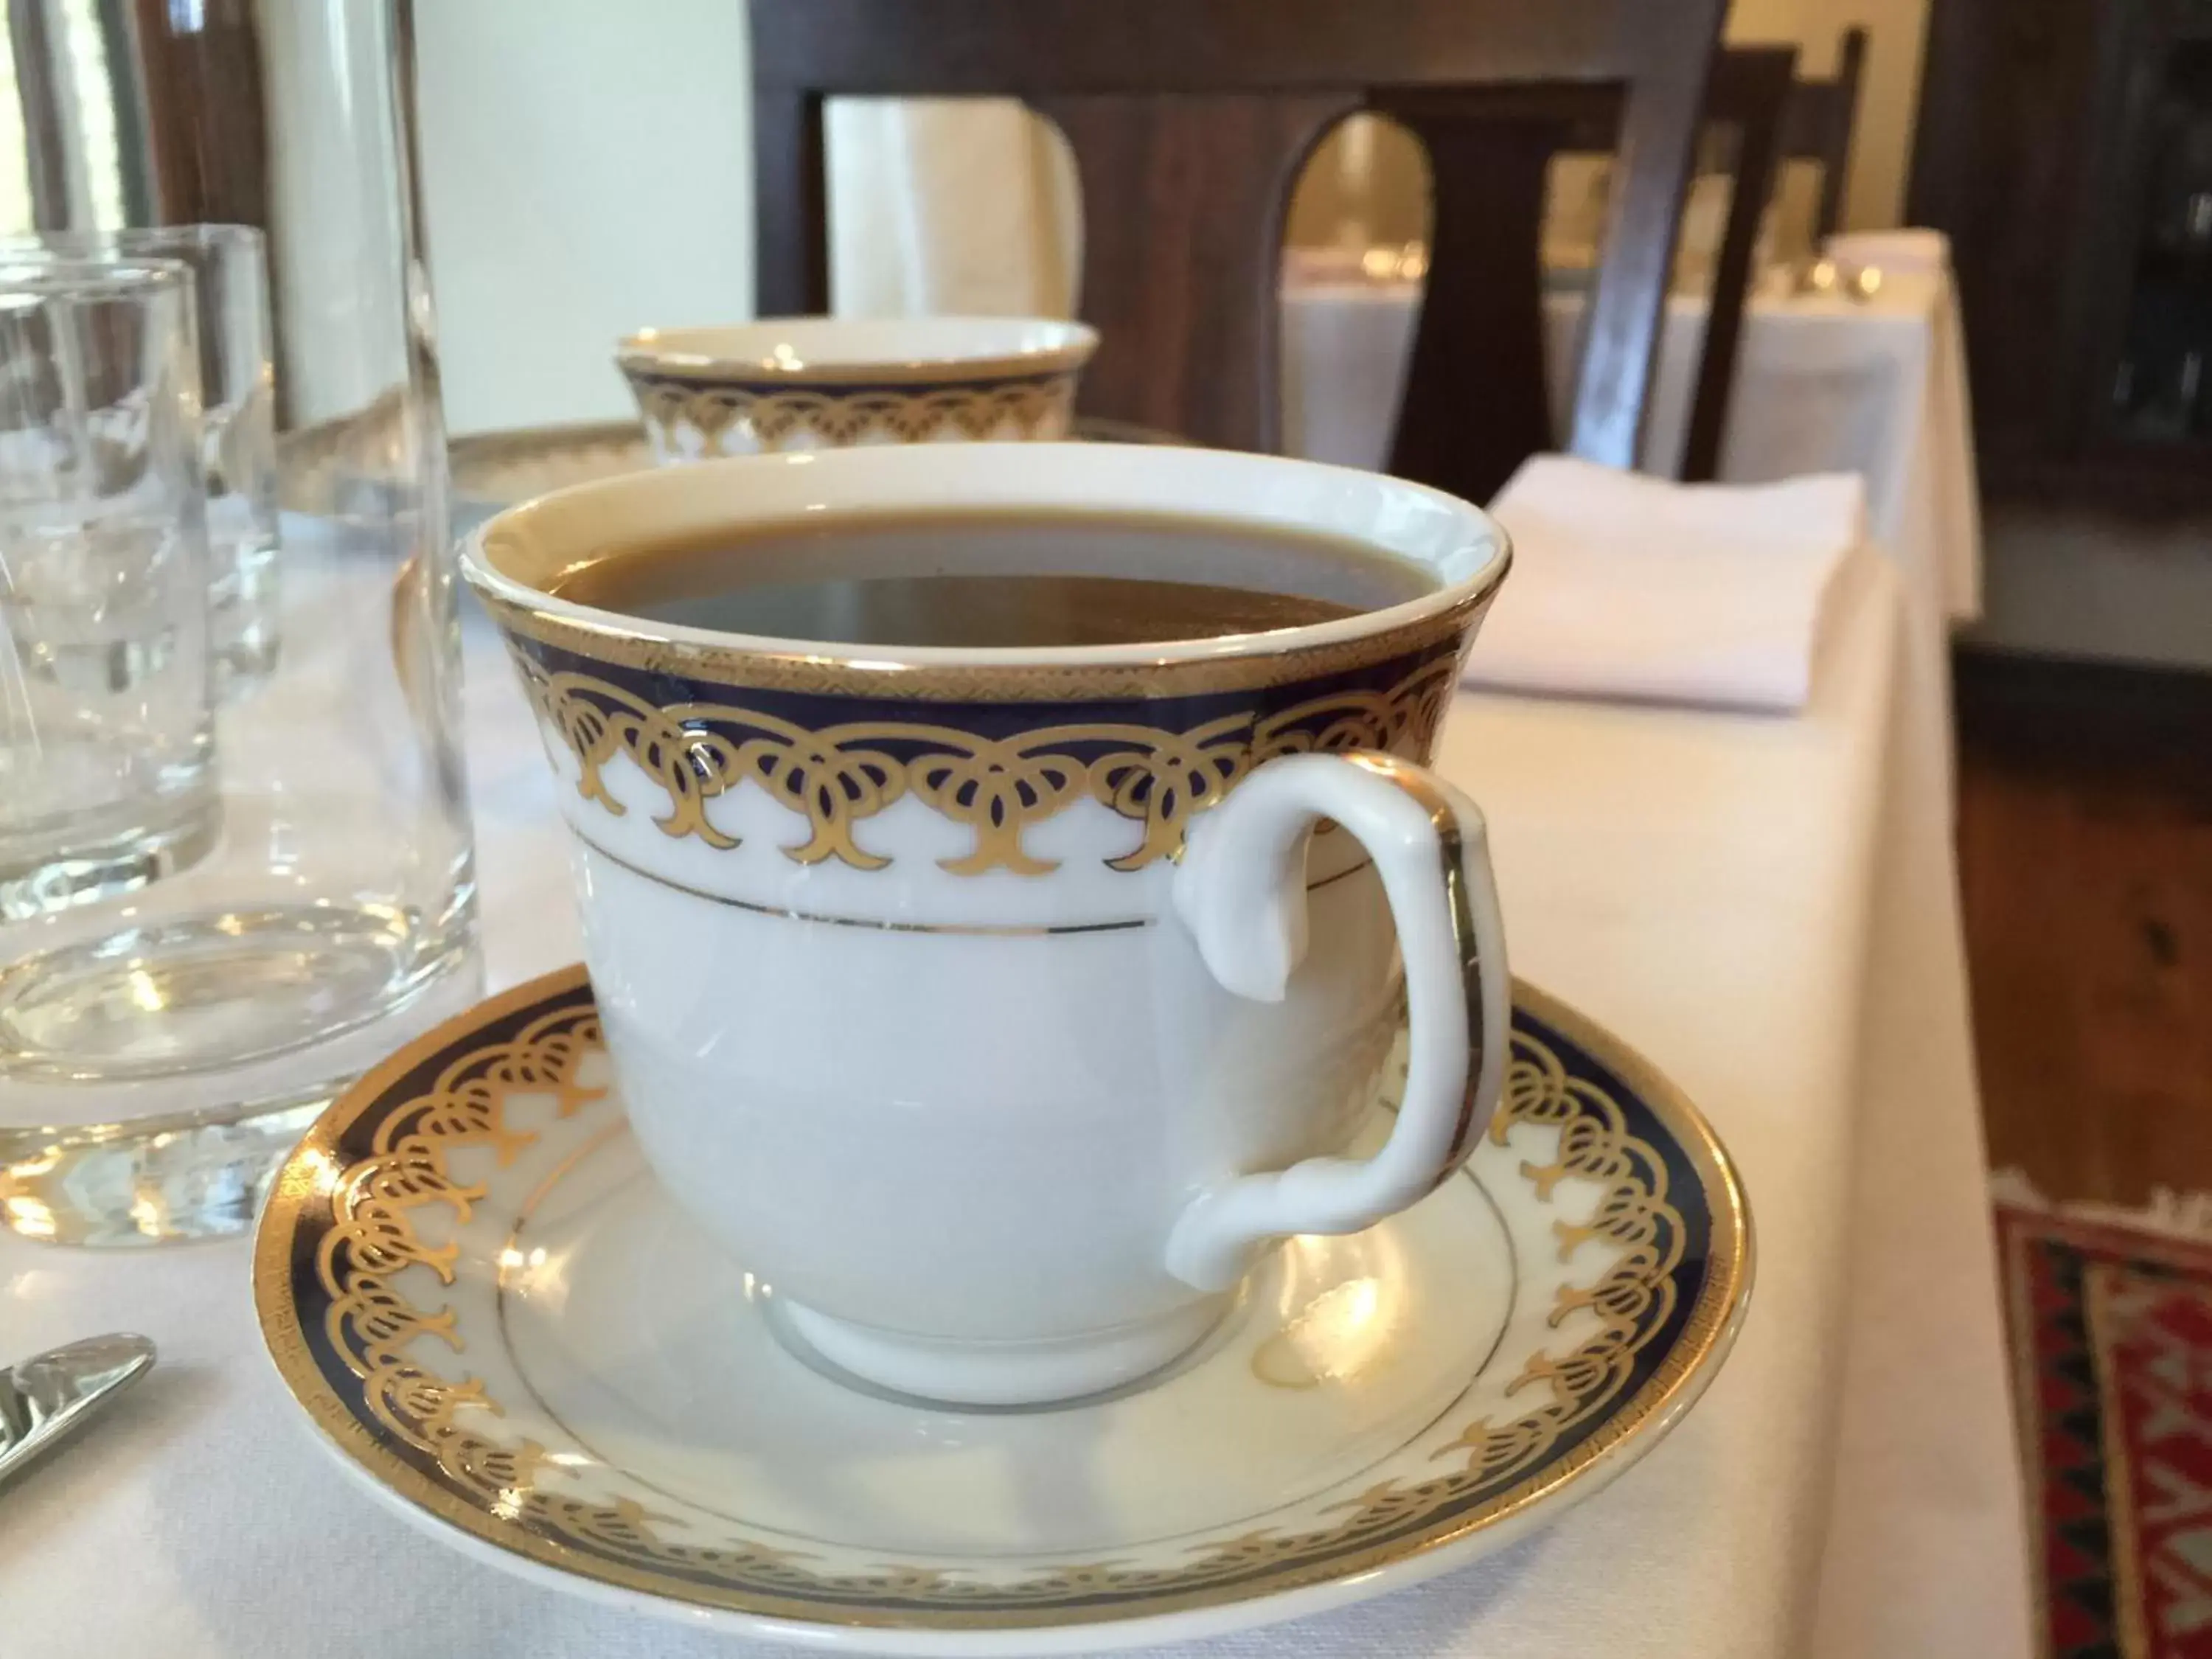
[{"left": 752, "top": 0, "right": 1725, "bottom": 476}]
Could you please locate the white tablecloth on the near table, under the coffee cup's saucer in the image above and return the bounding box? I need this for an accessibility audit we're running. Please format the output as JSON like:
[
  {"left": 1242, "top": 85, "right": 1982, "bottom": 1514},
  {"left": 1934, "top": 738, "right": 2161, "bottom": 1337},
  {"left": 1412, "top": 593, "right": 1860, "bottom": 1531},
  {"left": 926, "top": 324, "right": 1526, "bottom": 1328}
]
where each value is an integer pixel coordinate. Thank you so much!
[{"left": 0, "top": 542, "right": 2028, "bottom": 1659}]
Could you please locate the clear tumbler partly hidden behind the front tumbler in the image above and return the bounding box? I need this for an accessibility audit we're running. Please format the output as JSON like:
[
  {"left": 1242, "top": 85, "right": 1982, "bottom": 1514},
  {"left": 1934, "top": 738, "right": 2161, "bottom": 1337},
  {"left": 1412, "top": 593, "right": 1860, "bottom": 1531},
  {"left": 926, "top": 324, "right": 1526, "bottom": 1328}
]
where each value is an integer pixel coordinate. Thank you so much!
[{"left": 0, "top": 226, "right": 279, "bottom": 697}]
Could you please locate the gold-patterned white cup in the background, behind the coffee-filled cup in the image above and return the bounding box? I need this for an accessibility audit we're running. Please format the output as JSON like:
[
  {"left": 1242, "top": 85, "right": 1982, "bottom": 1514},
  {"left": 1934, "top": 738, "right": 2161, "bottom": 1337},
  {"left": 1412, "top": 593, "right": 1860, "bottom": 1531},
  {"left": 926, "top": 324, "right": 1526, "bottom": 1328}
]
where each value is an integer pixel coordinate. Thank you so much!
[{"left": 615, "top": 316, "right": 1097, "bottom": 462}]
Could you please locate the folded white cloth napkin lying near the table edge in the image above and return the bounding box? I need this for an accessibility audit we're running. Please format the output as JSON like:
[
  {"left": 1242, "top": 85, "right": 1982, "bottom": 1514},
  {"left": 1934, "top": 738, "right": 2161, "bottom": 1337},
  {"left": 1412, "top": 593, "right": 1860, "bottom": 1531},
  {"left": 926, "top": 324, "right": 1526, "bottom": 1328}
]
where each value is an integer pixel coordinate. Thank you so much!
[{"left": 1467, "top": 456, "right": 1867, "bottom": 710}]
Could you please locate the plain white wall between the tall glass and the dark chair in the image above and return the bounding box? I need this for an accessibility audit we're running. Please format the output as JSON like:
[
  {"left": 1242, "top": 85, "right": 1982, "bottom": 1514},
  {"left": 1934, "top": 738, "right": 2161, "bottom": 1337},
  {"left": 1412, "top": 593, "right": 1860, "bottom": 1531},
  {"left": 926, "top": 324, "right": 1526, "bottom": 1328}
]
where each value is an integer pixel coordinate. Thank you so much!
[{"left": 416, "top": 0, "right": 752, "bottom": 431}]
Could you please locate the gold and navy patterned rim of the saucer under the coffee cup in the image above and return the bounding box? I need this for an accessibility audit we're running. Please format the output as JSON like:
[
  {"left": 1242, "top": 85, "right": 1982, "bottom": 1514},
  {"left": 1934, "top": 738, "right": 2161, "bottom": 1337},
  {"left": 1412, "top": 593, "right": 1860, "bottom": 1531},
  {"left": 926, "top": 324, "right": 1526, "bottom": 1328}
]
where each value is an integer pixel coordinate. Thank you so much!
[{"left": 254, "top": 967, "right": 1752, "bottom": 1630}]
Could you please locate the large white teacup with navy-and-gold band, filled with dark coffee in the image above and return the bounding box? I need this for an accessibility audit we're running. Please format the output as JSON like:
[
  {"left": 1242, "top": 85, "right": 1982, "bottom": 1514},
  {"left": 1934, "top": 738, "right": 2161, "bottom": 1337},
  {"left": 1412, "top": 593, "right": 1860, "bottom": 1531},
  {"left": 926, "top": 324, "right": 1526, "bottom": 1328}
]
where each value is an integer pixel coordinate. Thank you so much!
[{"left": 465, "top": 445, "right": 1511, "bottom": 1402}]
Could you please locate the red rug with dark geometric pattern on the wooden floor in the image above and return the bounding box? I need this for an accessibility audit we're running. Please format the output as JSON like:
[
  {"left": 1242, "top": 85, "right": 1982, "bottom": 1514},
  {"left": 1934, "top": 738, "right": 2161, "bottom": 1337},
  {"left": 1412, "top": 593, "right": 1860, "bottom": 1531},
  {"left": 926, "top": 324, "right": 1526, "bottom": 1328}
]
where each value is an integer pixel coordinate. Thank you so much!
[{"left": 1997, "top": 1203, "right": 2212, "bottom": 1659}]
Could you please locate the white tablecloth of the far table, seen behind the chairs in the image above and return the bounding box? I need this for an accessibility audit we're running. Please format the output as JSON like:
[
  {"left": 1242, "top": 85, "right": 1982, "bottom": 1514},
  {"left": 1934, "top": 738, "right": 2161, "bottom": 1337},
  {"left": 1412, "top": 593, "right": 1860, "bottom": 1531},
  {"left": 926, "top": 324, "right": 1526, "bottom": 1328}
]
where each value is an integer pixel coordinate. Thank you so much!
[{"left": 1283, "top": 270, "right": 1982, "bottom": 622}]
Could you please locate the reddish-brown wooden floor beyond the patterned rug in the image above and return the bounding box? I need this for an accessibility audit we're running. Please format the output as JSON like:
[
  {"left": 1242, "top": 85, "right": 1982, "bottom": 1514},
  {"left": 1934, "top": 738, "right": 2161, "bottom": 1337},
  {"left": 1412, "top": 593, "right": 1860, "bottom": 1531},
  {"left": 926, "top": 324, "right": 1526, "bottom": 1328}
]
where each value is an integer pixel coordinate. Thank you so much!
[{"left": 1958, "top": 653, "right": 2212, "bottom": 1206}]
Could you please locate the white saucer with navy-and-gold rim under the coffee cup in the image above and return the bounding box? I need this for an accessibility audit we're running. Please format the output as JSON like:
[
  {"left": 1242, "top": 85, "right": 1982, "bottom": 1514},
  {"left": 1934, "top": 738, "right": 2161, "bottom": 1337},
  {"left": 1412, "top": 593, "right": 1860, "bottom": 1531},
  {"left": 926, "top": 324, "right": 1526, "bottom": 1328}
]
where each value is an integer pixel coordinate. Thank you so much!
[{"left": 254, "top": 969, "right": 1750, "bottom": 1655}]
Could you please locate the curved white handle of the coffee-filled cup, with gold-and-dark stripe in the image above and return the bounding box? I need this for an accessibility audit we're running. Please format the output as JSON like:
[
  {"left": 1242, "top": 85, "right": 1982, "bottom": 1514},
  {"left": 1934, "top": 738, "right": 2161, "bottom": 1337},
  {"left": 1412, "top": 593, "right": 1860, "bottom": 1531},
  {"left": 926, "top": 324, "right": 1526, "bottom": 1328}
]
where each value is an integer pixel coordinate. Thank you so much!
[{"left": 1168, "top": 750, "right": 1513, "bottom": 1290}]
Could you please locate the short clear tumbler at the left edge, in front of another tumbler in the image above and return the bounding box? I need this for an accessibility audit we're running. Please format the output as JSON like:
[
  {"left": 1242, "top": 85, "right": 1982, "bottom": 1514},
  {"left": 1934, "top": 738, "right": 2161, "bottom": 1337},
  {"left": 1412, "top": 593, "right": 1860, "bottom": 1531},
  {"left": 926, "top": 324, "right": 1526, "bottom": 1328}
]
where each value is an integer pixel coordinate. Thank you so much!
[{"left": 0, "top": 261, "right": 219, "bottom": 922}]
